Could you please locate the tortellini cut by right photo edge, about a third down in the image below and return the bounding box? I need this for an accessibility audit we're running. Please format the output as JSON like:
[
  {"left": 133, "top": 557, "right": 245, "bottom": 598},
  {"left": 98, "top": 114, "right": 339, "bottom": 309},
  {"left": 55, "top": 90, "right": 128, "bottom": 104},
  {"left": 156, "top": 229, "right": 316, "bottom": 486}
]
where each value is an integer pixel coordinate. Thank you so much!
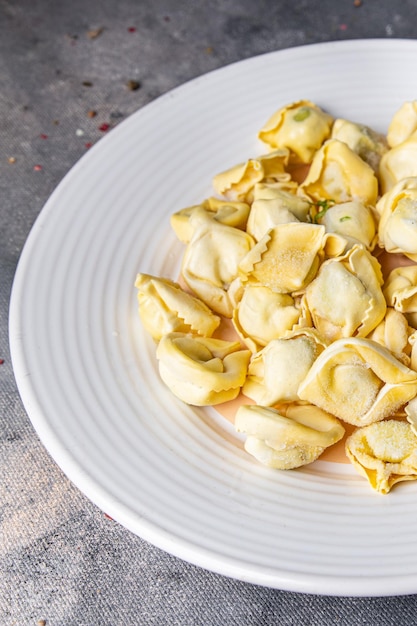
[{"left": 377, "top": 177, "right": 417, "bottom": 261}]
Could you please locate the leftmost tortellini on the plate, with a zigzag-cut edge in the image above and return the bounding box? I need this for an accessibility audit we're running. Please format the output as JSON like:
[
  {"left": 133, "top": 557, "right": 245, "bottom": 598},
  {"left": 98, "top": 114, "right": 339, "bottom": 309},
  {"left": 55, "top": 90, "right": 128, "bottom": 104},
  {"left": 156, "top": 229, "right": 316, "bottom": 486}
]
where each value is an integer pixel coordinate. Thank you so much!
[{"left": 135, "top": 274, "right": 220, "bottom": 341}]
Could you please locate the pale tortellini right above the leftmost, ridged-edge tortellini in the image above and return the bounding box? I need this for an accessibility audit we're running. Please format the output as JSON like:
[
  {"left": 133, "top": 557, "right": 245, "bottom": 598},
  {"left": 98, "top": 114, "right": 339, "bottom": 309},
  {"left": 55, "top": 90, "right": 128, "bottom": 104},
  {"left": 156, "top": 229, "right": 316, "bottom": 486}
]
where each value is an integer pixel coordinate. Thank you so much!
[{"left": 181, "top": 211, "right": 254, "bottom": 318}]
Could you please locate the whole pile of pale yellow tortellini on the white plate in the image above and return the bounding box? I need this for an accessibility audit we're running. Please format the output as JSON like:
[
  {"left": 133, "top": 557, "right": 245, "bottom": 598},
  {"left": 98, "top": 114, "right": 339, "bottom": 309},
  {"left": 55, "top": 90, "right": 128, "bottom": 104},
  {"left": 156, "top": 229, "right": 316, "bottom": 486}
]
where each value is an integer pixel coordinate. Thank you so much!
[{"left": 135, "top": 100, "right": 417, "bottom": 494}]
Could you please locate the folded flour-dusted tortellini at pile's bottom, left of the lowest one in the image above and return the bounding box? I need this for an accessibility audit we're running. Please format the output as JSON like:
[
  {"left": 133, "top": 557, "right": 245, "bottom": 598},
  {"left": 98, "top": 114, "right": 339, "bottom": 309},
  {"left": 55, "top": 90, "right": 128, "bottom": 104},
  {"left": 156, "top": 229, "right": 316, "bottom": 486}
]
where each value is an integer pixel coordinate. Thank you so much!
[{"left": 235, "top": 404, "right": 345, "bottom": 469}]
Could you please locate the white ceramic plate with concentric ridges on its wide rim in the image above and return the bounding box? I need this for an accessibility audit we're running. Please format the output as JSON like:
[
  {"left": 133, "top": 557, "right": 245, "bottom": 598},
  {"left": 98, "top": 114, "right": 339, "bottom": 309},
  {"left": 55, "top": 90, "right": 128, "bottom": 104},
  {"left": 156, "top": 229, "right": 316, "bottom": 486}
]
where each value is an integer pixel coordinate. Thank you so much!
[{"left": 10, "top": 40, "right": 417, "bottom": 596}]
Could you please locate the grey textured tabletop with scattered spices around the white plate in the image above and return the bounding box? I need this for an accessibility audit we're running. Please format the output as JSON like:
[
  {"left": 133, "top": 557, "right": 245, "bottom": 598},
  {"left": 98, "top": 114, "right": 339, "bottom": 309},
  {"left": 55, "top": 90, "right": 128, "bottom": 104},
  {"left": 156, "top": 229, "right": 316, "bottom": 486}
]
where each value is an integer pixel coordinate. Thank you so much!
[{"left": 0, "top": 0, "right": 417, "bottom": 626}]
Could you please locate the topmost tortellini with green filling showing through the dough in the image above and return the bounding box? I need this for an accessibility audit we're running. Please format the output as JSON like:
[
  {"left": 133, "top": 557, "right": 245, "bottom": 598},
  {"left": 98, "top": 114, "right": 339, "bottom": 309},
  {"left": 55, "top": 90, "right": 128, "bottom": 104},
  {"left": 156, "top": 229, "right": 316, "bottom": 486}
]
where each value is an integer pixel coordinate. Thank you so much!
[{"left": 258, "top": 100, "right": 333, "bottom": 163}]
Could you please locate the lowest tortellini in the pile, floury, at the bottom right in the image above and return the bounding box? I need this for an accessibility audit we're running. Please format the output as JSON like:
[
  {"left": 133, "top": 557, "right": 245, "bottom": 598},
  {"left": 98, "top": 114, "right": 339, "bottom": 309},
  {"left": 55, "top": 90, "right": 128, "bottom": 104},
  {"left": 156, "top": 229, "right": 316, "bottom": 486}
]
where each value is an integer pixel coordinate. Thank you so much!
[{"left": 346, "top": 419, "right": 417, "bottom": 494}]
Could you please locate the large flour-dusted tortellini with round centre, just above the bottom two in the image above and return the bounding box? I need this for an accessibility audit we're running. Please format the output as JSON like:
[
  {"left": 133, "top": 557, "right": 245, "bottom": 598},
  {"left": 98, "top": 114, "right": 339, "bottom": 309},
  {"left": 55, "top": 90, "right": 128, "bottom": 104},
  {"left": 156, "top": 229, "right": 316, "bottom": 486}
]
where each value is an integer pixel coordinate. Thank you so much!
[{"left": 298, "top": 337, "right": 417, "bottom": 426}]
